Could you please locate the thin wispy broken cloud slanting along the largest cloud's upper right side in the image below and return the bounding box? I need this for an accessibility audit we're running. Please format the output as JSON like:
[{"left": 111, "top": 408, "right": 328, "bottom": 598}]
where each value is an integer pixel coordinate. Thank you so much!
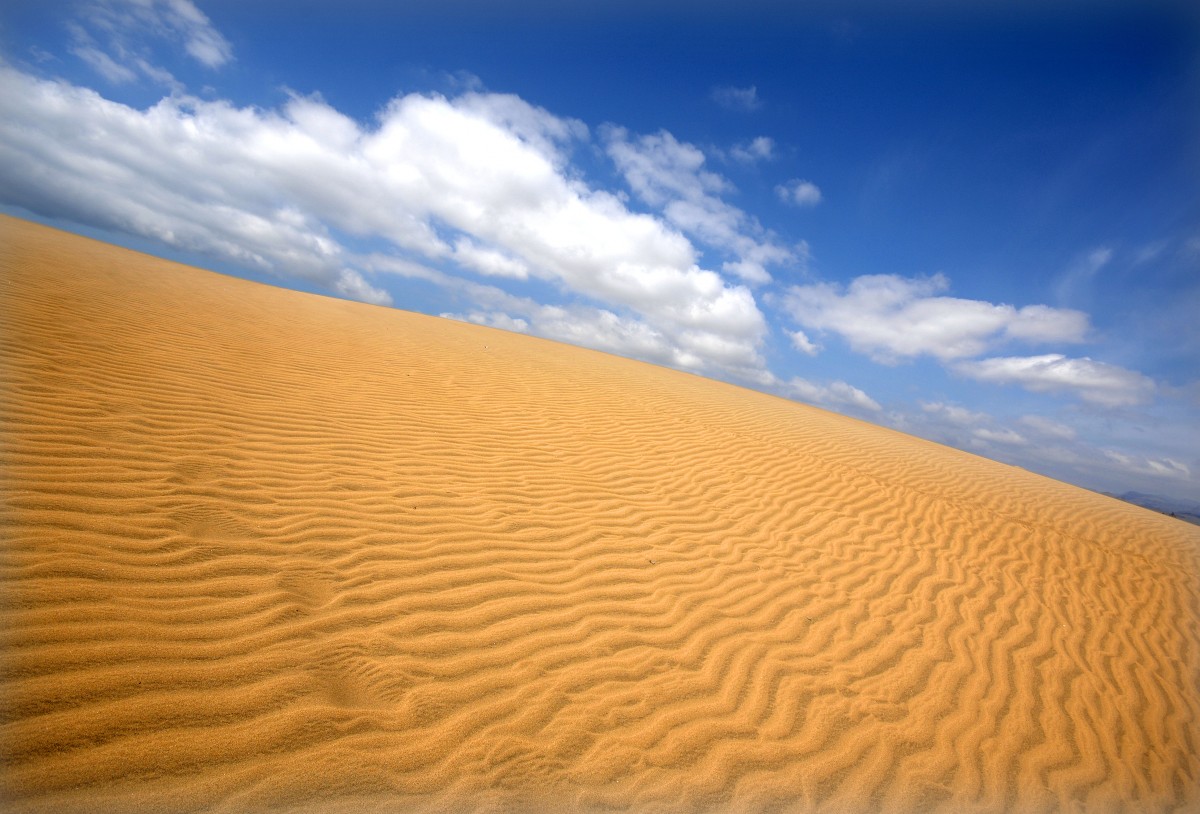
[{"left": 605, "top": 127, "right": 796, "bottom": 283}]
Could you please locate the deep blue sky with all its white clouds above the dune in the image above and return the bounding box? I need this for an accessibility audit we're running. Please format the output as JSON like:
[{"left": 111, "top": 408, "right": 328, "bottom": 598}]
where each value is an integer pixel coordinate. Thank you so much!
[{"left": 0, "top": 0, "right": 1200, "bottom": 501}]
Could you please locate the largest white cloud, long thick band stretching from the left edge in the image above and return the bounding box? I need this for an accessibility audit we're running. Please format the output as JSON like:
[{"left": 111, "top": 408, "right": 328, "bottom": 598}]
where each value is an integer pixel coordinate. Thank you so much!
[{"left": 0, "top": 67, "right": 766, "bottom": 377}]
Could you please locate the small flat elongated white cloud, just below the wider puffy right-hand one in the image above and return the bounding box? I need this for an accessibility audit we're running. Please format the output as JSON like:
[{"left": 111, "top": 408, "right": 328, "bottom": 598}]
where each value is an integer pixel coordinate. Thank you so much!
[{"left": 954, "top": 353, "right": 1154, "bottom": 407}]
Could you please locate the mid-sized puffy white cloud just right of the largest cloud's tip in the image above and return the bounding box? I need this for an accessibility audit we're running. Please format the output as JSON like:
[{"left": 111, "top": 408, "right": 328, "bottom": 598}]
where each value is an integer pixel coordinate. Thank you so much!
[{"left": 784, "top": 274, "right": 1088, "bottom": 364}]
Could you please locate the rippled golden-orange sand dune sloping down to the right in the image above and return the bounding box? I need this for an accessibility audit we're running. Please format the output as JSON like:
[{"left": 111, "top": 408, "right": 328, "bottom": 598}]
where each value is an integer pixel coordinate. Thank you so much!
[{"left": 0, "top": 212, "right": 1200, "bottom": 812}]
